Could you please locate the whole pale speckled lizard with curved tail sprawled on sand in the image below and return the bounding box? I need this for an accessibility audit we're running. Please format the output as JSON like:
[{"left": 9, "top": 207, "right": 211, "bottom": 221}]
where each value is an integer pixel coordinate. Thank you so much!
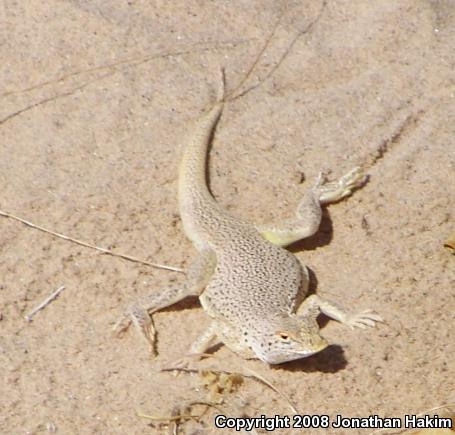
[{"left": 114, "top": 75, "right": 382, "bottom": 364}]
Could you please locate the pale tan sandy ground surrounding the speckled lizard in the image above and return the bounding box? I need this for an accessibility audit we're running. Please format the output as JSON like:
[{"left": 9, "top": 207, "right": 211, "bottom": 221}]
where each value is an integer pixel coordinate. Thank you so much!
[{"left": 0, "top": 0, "right": 455, "bottom": 434}]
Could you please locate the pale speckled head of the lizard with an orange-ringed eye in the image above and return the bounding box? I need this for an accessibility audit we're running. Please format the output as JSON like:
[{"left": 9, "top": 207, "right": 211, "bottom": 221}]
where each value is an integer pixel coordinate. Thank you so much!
[{"left": 251, "top": 314, "right": 328, "bottom": 364}]
